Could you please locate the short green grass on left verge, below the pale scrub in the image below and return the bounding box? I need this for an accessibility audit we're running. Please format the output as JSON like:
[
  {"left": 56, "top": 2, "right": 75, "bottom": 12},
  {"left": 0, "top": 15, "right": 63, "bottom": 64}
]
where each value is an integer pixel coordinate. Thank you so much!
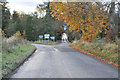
[{"left": 2, "top": 44, "right": 35, "bottom": 76}]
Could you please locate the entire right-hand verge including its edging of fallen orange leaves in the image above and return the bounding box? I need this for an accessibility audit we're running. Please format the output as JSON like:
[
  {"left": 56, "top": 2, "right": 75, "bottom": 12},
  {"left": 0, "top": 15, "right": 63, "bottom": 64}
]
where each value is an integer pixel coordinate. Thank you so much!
[{"left": 70, "top": 41, "right": 120, "bottom": 67}]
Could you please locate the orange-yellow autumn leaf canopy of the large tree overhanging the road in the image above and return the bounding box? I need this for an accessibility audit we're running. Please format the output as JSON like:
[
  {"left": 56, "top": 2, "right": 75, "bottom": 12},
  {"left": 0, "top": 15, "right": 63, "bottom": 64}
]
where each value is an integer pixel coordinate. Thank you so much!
[{"left": 49, "top": 2, "right": 109, "bottom": 41}]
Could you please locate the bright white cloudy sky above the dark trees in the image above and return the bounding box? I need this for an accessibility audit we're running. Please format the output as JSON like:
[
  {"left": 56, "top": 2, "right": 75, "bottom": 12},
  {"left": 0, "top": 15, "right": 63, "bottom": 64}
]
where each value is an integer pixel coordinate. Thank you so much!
[{"left": 7, "top": 0, "right": 50, "bottom": 13}]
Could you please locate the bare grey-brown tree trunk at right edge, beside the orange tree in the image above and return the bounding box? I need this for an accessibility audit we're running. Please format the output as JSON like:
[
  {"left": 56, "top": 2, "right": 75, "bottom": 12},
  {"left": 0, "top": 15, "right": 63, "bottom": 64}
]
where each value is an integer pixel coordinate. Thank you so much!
[{"left": 96, "top": 0, "right": 120, "bottom": 42}]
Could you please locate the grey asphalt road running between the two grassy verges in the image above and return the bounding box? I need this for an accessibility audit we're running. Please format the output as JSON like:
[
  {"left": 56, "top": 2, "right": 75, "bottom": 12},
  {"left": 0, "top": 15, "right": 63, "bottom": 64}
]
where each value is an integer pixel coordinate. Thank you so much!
[{"left": 11, "top": 43, "right": 118, "bottom": 78}]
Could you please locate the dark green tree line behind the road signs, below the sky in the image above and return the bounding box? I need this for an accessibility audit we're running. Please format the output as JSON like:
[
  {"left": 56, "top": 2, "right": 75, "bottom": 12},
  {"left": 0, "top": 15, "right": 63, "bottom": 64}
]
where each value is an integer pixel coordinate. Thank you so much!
[{"left": 0, "top": 1, "right": 67, "bottom": 41}]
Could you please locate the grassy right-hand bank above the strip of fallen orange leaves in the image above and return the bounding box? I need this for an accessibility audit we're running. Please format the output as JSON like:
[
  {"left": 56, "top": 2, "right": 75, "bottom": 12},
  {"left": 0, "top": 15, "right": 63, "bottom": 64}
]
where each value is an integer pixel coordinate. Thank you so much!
[{"left": 71, "top": 41, "right": 120, "bottom": 64}]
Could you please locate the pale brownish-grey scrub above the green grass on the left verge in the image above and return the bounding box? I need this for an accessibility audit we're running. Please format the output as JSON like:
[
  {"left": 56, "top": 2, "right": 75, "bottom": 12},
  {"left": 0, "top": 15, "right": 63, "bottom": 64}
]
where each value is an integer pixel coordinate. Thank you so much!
[{"left": 2, "top": 32, "right": 28, "bottom": 53}]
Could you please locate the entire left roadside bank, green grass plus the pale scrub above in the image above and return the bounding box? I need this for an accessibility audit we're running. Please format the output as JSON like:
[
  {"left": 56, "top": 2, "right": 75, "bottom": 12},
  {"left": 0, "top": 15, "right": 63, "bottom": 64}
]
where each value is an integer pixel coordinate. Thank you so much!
[{"left": 0, "top": 31, "right": 35, "bottom": 76}]
